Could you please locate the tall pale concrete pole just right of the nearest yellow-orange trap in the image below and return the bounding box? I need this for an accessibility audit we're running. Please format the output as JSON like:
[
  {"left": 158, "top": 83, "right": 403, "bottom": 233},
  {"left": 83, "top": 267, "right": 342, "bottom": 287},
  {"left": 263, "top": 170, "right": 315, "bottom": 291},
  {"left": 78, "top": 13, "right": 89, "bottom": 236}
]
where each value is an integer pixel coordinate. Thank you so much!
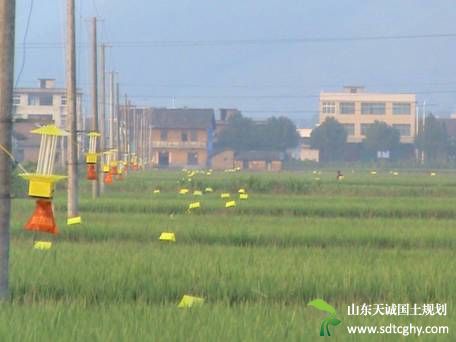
[{"left": 66, "top": 0, "right": 79, "bottom": 218}]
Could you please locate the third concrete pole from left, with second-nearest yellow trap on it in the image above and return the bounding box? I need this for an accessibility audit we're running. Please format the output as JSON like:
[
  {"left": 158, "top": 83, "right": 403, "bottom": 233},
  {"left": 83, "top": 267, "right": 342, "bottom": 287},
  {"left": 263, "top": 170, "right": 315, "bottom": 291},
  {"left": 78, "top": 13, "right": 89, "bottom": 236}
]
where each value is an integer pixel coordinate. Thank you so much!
[{"left": 92, "top": 17, "right": 99, "bottom": 199}]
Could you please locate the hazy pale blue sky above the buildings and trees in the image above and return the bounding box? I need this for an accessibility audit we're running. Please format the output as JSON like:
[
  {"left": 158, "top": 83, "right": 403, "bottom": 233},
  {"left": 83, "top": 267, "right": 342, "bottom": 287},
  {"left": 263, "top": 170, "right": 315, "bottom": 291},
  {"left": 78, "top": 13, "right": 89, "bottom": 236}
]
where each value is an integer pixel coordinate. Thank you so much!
[{"left": 16, "top": 0, "right": 456, "bottom": 124}]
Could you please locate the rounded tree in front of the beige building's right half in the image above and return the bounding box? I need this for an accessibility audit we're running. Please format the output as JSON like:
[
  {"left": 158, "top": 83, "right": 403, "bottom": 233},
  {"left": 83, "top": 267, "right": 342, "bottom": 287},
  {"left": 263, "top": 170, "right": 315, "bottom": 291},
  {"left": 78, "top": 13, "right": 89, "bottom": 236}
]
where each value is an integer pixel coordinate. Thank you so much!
[{"left": 364, "top": 121, "right": 400, "bottom": 159}]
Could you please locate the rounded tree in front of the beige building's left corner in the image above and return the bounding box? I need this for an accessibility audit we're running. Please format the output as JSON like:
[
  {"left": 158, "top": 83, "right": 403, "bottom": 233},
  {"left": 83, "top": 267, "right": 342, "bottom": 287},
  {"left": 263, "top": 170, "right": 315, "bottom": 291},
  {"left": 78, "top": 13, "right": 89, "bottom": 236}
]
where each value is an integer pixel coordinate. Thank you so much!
[{"left": 310, "top": 117, "right": 347, "bottom": 161}]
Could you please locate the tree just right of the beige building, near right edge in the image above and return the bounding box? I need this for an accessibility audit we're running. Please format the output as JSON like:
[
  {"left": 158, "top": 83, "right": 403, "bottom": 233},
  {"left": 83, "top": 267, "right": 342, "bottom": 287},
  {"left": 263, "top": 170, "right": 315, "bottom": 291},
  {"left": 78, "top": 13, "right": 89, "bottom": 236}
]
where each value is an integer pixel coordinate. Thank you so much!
[{"left": 415, "top": 114, "right": 449, "bottom": 162}]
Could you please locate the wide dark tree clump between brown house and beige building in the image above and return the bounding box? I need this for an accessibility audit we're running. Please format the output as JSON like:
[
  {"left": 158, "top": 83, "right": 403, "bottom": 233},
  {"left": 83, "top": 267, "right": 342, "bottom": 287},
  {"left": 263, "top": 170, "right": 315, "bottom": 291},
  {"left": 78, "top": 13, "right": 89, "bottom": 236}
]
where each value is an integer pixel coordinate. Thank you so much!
[{"left": 216, "top": 114, "right": 299, "bottom": 152}]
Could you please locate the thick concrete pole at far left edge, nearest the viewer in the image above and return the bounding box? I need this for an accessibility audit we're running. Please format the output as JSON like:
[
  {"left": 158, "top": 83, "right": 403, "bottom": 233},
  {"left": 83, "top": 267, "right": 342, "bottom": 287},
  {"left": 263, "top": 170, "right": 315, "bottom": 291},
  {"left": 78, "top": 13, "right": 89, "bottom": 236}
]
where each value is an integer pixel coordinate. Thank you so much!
[{"left": 0, "top": 0, "right": 16, "bottom": 300}]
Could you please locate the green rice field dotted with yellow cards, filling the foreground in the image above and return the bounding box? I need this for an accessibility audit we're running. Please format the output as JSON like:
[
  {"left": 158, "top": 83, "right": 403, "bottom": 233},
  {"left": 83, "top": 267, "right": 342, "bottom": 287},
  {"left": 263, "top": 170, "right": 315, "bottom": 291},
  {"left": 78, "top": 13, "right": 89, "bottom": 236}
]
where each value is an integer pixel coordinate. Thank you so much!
[{"left": 0, "top": 170, "right": 456, "bottom": 341}]
